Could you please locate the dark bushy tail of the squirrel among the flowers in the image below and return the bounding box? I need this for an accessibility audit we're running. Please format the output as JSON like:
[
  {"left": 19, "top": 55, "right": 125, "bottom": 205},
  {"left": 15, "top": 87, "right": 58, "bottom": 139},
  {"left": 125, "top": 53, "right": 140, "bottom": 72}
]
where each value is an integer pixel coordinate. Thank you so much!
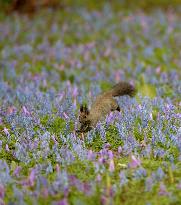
[{"left": 109, "top": 81, "right": 136, "bottom": 97}]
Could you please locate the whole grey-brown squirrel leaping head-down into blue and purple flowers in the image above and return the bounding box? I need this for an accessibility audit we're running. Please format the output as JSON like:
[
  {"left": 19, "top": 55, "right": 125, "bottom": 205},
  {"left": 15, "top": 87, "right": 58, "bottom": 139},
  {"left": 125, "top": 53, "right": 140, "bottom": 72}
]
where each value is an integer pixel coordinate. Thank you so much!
[{"left": 76, "top": 82, "right": 136, "bottom": 133}]
